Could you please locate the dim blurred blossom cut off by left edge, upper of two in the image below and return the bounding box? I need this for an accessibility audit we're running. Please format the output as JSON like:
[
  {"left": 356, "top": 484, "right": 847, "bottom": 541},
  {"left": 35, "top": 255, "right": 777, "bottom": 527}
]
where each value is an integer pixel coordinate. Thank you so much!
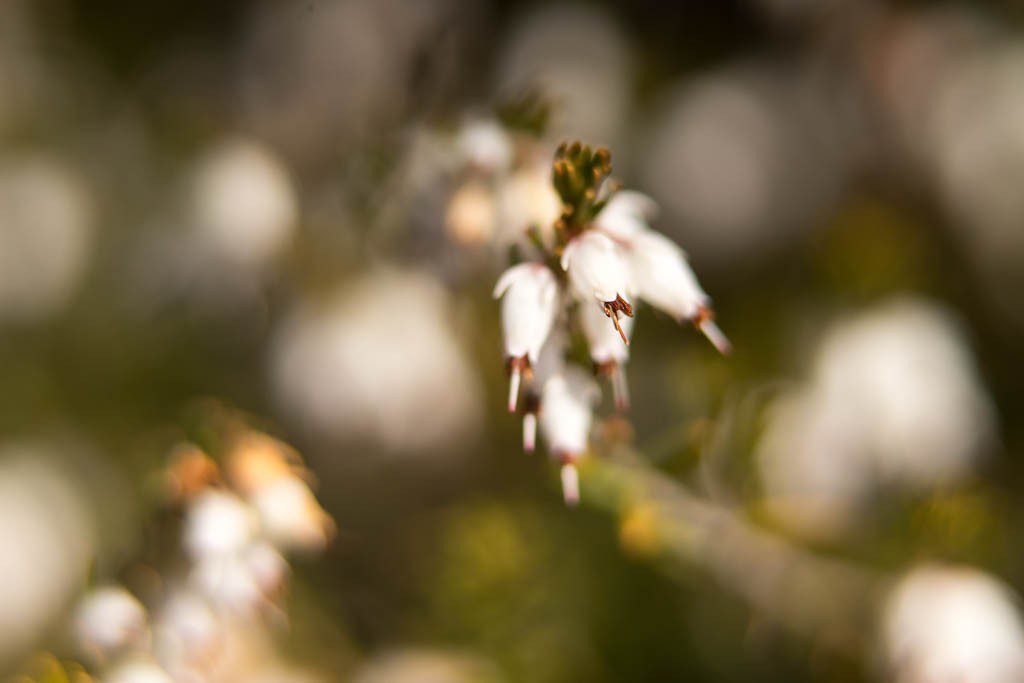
[{"left": 0, "top": 156, "right": 92, "bottom": 321}]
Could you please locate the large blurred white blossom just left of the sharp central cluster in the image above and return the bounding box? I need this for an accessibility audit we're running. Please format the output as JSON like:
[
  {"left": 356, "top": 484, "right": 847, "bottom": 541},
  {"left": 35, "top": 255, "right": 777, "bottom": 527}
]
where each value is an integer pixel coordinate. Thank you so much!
[{"left": 271, "top": 270, "right": 480, "bottom": 455}]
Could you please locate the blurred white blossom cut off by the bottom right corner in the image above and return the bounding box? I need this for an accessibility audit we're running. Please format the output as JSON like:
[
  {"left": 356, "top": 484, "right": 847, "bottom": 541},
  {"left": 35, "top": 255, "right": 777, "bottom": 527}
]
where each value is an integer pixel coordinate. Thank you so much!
[{"left": 883, "top": 566, "right": 1024, "bottom": 683}]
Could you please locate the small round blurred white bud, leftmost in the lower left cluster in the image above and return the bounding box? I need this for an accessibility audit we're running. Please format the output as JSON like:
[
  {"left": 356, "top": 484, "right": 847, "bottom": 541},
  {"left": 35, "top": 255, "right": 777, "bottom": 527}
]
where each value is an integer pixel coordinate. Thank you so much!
[{"left": 74, "top": 586, "right": 147, "bottom": 660}]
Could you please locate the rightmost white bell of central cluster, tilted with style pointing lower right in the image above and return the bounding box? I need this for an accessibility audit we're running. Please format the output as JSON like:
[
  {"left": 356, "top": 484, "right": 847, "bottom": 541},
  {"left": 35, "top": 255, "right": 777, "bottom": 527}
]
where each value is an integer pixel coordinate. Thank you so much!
[{"left": 626, "top": 230, "right": 731, "bottom": 353}]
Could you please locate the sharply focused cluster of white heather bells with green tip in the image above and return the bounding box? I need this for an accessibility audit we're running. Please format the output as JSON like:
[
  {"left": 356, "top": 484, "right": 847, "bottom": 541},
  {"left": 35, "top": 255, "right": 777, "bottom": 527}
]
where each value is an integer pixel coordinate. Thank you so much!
[{"left": 494, "top": 142, "right": 729, "bottom": 504}]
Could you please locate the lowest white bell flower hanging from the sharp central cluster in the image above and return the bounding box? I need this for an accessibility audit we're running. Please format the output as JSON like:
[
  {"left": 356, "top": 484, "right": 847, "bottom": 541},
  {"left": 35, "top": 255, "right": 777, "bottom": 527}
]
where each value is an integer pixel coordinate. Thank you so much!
[{"left": 541, "top": 367, "right": 600, "bottom": 505}]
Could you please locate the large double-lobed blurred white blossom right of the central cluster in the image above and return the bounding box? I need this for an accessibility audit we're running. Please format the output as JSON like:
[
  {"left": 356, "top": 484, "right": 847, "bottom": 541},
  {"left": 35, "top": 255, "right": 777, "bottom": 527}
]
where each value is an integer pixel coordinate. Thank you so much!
[{"left": 759, "top": 299, "right": 994, "bottom": 530}]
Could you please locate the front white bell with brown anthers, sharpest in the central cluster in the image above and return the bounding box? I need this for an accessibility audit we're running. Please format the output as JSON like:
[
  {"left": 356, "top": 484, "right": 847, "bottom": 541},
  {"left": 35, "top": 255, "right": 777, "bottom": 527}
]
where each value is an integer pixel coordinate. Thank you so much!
[{"left": 562, "top": 230, "right": 633, "bottom": 344}]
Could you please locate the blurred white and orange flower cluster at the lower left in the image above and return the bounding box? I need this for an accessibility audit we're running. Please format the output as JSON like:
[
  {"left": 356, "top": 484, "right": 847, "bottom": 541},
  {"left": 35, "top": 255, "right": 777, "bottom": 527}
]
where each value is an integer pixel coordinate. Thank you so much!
[{"left": 73, "top": 429, "right": 334, "bottom": 683}]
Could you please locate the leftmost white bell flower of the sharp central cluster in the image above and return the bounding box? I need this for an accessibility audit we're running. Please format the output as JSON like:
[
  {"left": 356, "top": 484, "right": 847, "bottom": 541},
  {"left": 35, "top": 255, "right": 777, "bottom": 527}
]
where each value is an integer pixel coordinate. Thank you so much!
[{"left": 494, "top": 263, "right": 558, "bottom": 412}]
